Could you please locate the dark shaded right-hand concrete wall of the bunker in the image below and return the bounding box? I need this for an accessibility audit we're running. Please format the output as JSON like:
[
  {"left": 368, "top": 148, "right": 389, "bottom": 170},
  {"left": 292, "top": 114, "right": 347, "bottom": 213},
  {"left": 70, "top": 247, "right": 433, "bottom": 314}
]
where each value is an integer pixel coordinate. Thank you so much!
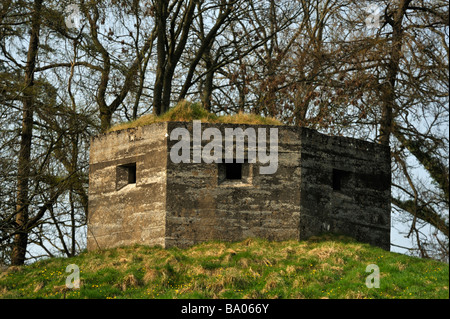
[{"left": 300, "top": 129, "right": 391, "bottom": 250}]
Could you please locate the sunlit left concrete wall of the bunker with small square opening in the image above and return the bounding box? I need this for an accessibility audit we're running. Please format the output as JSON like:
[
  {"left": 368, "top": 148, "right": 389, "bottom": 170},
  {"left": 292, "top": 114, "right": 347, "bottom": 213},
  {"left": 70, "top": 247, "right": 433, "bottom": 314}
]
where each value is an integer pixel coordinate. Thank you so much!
[{"left": 87, "top": 123, "right": 167, "bottom": 250}]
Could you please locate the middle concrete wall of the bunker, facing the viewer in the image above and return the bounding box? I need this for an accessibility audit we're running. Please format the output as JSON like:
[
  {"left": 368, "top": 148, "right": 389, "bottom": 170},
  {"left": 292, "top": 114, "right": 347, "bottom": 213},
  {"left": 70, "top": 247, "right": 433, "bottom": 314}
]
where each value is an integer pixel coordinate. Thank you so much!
[{"left": 166, "top": 123, "right": 300, "bottom": 246}]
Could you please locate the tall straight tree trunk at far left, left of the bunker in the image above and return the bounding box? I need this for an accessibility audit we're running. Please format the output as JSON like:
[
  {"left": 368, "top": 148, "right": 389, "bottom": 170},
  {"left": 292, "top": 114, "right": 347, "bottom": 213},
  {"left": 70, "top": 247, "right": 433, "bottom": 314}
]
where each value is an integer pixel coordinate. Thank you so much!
[{"left": 11, "top": 0, "right": 43, "bottom": 265}]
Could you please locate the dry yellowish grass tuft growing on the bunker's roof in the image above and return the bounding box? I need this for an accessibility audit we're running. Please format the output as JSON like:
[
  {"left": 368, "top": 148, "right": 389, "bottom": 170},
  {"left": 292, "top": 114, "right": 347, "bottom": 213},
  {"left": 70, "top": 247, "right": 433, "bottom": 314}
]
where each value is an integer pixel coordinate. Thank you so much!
[{"left": 109, "top": 101, "right": 282, "bottom": 132}]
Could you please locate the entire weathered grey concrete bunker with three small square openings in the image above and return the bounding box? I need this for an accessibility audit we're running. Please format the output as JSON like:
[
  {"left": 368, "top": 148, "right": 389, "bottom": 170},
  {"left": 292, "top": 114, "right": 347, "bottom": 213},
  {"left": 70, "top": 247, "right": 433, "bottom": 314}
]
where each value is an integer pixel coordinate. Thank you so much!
[{"left": 88, "top": 122, "right": 391, "bottom": 250}]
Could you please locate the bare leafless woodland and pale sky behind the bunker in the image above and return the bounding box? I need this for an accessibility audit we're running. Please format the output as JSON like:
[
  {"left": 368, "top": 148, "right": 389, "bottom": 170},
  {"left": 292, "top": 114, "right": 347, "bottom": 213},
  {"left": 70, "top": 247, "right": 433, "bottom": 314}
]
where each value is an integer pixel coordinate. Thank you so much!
[{"left": 0, "top": 0, "right": 449, "bottom": 265}]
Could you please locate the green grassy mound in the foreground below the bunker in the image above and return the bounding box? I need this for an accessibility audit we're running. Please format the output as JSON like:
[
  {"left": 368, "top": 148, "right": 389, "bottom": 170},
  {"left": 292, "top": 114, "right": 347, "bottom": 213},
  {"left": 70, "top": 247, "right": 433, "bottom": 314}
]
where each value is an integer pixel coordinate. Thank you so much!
[{"left": 0, "top": 236, "right": 449, "bottom": 299}]
